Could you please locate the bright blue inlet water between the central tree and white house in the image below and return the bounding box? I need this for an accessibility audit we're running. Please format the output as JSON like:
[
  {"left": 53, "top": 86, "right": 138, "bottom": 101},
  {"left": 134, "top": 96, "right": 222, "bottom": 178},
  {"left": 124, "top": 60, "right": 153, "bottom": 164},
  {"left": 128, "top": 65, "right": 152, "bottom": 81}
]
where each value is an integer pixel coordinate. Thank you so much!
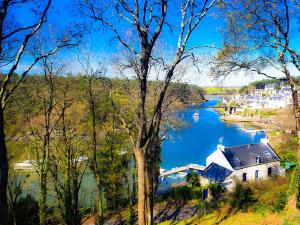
[{"left": 161, "top": 99, "right": 261, "bottom": 170}]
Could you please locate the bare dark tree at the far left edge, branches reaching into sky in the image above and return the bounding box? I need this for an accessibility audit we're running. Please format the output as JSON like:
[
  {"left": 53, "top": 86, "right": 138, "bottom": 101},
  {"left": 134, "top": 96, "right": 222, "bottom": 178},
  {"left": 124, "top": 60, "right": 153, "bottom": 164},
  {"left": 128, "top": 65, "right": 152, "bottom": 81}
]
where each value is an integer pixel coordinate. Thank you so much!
[{"left": 0, "top": 0, "right": 79, "bottom": 225}]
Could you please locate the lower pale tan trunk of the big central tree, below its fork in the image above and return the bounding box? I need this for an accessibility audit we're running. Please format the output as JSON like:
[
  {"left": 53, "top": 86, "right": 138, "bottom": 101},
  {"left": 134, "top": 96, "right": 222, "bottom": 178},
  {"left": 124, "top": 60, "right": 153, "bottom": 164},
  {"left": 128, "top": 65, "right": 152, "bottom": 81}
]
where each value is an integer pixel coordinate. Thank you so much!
[{"left": 136, "top": 149, "right": 146, "bottom": 225}]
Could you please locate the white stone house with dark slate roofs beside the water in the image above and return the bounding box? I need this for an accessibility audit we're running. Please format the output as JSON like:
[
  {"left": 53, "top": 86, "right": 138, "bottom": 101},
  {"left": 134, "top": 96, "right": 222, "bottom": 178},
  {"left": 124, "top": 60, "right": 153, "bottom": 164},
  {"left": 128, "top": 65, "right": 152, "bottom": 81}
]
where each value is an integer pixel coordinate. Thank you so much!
[{"left": 202, "top": 139, "right": 284, "bottom": 190}]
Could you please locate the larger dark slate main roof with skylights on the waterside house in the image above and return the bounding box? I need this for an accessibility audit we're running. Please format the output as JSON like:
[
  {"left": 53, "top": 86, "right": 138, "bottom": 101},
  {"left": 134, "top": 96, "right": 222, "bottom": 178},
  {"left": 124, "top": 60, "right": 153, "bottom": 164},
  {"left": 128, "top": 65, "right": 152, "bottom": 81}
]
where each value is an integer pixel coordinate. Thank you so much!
[{"left": 223, "top": 143, "right": 280, "bottom": 169}]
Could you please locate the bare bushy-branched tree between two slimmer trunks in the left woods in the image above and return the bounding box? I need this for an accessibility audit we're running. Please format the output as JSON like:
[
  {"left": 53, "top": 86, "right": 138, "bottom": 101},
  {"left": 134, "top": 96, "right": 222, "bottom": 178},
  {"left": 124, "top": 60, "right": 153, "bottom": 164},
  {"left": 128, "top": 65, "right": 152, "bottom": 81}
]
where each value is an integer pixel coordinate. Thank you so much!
[{"left": 50, "top": 87, "right": 89, "bottom": 225}]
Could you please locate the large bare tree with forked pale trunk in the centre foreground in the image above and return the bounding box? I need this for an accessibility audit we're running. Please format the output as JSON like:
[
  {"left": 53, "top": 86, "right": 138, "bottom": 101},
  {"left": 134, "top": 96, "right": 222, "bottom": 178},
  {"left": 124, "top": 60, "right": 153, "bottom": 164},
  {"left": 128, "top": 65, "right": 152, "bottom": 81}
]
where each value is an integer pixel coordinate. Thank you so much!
[{"left": 80, "top": 0, "right": 215, "bottom": 225}]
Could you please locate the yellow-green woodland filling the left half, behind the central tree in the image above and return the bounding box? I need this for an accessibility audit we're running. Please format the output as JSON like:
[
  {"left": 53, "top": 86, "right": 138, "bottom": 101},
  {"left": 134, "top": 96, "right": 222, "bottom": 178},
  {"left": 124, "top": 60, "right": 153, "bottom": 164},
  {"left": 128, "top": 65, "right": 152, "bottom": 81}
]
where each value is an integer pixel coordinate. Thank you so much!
[{"left": 2, "top": 72, "right": 204, "bottom": 224}]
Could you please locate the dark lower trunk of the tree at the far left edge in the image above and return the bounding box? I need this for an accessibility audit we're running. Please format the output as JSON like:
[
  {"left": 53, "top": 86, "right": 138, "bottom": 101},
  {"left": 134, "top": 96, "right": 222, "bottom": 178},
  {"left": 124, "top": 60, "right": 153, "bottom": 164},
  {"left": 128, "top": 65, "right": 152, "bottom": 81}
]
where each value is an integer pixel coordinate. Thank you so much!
[{"left": 0, "top": 106, "right": 8, "bottom": 225}]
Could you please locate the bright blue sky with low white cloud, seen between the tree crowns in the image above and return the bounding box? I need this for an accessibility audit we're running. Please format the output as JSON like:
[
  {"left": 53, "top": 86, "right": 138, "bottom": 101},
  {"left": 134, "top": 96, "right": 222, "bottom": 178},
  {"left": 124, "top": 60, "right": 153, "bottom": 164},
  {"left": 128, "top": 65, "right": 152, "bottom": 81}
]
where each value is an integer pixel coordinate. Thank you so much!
[{"left": 4, "top": 0, "right": 300, "bottom": 86}]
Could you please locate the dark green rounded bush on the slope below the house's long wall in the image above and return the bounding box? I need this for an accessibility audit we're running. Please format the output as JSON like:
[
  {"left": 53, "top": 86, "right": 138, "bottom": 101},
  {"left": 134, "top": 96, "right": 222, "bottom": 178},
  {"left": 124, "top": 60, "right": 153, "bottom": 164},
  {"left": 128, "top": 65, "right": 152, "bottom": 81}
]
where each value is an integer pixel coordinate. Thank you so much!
[{"left": 231, "top": 183, "right": 255, "bottom": 211}]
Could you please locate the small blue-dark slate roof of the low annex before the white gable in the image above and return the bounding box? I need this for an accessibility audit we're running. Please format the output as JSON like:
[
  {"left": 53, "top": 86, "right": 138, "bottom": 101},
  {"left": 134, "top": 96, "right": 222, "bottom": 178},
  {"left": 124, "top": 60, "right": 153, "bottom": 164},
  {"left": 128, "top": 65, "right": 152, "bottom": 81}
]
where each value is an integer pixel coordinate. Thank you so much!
[{"left": 202, "top": 163, "right": 232, "bottom": 182}]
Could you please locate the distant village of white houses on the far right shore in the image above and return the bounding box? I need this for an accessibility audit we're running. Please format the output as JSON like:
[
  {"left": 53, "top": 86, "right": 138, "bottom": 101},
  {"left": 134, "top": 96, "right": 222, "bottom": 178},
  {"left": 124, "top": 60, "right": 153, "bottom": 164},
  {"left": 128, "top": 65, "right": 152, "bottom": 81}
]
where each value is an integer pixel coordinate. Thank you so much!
[{"left": 222, "top": 83, "right": 292, "bottom": 111}]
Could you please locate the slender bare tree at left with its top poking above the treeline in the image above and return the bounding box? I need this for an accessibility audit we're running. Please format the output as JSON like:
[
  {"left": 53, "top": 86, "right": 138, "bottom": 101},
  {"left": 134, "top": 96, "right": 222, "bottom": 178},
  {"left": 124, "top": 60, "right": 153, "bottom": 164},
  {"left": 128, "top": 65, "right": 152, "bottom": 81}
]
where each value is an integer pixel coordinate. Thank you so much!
[{"left": 31, "top": 56, "right": 64, "bottom": 224}]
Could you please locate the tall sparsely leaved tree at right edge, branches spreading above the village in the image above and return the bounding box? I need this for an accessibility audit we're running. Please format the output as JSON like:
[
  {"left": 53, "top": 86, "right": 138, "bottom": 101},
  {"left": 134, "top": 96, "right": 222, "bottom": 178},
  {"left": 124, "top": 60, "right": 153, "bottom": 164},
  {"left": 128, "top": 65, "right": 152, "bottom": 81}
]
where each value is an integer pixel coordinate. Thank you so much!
[{"left": 212, "top": 0, "right": 300, "bottom": 207}]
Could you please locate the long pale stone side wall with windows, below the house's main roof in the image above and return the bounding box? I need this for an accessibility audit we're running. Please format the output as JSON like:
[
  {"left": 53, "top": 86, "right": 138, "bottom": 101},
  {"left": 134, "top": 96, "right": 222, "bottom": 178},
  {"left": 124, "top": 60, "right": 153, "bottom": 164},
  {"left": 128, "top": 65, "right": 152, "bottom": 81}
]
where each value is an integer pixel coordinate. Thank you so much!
[{"left": 223, "top": 162, "right": 280, "bottom": 190}]
